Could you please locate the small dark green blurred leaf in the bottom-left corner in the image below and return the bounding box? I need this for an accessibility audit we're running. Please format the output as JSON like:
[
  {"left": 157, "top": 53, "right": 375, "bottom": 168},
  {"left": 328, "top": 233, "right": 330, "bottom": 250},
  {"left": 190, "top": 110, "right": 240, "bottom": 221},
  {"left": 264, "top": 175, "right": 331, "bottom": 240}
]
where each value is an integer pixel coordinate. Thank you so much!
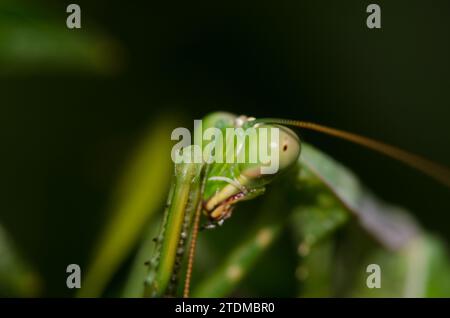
[{"left": 0, "top": 226, "right": 42, "bottom": 297}]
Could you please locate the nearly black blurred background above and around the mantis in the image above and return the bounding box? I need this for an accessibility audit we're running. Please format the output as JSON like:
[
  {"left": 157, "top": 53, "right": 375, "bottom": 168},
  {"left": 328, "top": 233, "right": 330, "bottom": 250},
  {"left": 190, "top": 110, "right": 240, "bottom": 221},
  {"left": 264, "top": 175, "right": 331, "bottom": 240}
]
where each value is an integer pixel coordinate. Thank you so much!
[{"left": 0, "top": 0, "right": 450, "bottom": 295}]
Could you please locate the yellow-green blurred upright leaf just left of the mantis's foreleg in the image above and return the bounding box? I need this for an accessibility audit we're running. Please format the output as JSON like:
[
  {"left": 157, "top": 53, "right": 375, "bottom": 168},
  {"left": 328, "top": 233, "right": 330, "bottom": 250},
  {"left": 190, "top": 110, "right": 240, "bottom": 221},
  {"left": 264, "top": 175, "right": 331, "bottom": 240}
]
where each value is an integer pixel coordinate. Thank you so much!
[{"left": 79, "top": 118, "right": 174, "bottom": 297}]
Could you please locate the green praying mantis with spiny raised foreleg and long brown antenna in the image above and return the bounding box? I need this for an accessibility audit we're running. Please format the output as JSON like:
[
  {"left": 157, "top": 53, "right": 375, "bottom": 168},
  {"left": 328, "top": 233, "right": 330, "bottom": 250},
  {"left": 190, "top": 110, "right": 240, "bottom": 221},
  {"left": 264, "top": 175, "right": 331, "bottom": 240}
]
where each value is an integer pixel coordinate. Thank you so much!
[{"left": 144, "top": 113, "right": 450, "bottom": 297}]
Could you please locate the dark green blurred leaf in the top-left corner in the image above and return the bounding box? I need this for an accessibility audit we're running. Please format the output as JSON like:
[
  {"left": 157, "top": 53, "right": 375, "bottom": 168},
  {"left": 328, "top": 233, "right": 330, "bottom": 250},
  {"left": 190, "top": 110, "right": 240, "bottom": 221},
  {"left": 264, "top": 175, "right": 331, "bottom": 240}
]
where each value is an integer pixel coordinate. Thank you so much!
[{"left": 0, "top": 0, "right": 121, "bottom": 75}]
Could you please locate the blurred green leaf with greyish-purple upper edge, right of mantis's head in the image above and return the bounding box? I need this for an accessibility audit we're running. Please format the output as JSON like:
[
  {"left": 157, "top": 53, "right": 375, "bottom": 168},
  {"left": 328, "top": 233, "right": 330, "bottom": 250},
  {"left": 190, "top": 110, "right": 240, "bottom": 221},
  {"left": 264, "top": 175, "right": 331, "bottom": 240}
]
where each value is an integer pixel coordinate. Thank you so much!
[{"left": 290, "top": 145, "right": 445, "bottom": 297}]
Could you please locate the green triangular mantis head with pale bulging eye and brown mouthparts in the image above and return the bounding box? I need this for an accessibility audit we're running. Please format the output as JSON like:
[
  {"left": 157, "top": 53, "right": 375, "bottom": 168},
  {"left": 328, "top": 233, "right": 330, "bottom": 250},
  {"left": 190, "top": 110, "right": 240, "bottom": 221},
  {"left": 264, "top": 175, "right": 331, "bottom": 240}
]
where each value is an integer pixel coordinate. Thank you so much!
[{"left": 203, "top": 113, "right": 301, "bottom": 228}]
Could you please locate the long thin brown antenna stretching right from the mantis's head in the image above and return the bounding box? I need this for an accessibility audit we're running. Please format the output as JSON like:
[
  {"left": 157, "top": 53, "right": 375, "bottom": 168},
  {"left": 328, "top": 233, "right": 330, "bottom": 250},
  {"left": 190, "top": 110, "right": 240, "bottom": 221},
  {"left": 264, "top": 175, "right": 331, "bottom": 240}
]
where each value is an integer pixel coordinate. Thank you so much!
[{"left": 253, "top": 118, "right": 450, "bottom": 187}]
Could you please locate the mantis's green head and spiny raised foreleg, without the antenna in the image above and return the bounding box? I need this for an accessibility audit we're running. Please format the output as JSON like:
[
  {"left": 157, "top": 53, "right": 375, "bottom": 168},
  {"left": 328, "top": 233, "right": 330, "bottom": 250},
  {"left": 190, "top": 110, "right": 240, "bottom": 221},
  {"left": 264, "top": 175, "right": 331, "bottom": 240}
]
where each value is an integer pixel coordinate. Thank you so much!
[{"left": 146, "top": 113, "right": 300, "bottom": 296}]
